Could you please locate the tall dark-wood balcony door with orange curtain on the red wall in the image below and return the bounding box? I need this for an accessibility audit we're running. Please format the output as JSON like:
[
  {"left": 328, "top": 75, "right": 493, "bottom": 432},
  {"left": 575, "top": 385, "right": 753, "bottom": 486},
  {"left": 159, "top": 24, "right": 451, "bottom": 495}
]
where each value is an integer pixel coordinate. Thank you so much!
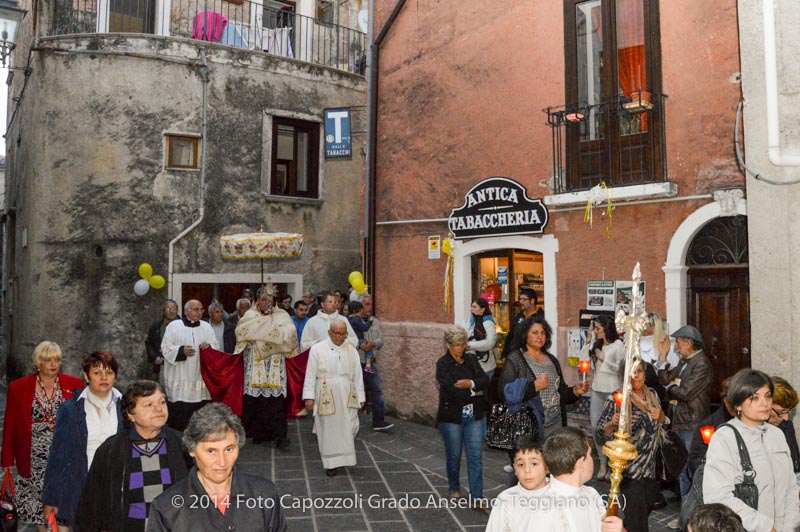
[{"left": 561, "top": 0, "right": 666, "bottom": 191}]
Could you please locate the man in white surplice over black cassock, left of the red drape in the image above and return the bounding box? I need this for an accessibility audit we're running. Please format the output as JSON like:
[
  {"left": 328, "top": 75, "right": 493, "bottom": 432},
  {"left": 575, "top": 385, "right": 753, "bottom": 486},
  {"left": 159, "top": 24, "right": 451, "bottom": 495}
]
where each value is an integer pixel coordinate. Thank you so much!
[{"left": 161, "top": 299, "right": 220, "bottom": 431}]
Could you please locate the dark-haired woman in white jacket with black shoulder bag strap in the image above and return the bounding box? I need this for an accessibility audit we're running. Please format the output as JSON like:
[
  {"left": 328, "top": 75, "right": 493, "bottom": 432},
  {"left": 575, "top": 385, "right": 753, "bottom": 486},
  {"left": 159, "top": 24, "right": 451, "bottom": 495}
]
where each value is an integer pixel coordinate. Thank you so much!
[{"left": 703, "top": 369, "right": 800, "bottom": 532}]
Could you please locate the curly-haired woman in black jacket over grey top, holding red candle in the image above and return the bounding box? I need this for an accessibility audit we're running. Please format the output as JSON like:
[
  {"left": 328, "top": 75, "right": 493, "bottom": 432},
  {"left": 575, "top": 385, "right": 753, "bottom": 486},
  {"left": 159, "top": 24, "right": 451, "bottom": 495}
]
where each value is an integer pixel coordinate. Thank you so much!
[{"left": 500, "top": 316, "right": 589, "bottom": 439}]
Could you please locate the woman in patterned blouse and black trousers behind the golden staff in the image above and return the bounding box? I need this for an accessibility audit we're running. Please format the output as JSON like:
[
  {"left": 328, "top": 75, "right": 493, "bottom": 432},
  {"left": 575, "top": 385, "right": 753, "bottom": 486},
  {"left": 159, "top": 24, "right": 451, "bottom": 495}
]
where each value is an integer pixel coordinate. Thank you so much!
[{"left": 595, "top": 364, "right": 666, "bottom": 532}]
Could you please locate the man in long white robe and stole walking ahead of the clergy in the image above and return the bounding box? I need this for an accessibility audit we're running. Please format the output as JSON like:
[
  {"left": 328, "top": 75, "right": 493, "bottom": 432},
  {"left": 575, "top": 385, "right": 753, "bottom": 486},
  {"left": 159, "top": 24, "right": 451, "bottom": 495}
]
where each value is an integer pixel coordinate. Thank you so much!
[{"left": 303, "top": 321, "right": 365, "bottom": 477}]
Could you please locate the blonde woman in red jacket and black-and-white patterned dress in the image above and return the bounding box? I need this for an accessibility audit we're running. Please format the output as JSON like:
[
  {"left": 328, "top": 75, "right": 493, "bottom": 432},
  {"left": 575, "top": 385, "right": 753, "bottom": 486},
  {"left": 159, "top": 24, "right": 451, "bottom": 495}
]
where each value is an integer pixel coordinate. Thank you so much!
[{"left": 0, "top": 341, "right": 83, "bottom": 532}]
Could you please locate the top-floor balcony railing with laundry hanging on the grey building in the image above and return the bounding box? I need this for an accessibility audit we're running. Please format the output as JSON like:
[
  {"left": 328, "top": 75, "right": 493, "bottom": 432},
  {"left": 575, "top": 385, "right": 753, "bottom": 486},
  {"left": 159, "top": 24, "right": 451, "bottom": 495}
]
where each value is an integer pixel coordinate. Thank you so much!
[{"left": 50, "top": 0, "right": 366, "bottom": 75}]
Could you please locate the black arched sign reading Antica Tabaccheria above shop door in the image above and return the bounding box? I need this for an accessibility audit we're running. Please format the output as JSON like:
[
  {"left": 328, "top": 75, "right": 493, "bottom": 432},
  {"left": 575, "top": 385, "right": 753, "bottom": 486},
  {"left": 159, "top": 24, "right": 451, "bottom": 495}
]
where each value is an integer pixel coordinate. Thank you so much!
[{"left": 448, "top": 177, "right": 548, "bottom": 239}]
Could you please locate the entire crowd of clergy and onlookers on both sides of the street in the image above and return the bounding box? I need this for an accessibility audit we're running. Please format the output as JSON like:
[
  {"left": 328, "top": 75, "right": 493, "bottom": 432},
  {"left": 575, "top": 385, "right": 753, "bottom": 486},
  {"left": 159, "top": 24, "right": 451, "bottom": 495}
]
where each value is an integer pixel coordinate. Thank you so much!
[{"left": 0, "top": 286, "right": 800, "bottom": 532}]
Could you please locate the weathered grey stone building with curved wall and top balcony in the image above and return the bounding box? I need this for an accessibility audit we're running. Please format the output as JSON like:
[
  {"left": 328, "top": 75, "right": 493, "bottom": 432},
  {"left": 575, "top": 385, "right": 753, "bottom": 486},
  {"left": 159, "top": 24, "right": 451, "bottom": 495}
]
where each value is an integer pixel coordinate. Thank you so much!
[{"left": 3, "top": 0, "right": 366, "bottom": 381}]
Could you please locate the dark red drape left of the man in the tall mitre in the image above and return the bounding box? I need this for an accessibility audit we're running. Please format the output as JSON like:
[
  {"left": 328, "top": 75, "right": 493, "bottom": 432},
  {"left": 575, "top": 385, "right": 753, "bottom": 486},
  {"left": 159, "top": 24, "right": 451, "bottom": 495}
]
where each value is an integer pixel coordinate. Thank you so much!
[{"left": 200, "top": 347, "right": 244, "bottom": 416}]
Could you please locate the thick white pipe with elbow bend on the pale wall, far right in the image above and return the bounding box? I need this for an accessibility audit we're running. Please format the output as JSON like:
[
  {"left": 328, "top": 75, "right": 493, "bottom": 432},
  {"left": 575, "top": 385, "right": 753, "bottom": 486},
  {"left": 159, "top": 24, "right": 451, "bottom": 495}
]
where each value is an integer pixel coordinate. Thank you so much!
[{"left": 762, "top": 0, "right": 800, "bottom": 166}]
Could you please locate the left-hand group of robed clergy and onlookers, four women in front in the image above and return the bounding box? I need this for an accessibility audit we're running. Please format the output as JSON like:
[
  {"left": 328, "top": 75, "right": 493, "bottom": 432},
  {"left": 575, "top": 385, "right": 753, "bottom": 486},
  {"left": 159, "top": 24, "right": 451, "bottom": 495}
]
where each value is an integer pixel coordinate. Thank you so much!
[{"left": 2, "top": 286, "right": 393, "bottom": 532}]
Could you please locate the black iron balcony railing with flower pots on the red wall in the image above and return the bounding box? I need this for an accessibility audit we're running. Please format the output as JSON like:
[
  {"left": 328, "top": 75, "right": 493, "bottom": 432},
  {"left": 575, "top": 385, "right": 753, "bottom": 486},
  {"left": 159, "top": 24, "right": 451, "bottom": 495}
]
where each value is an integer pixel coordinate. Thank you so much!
[{"left": 544, "top": 91, "right": 667, "bottom": 194}]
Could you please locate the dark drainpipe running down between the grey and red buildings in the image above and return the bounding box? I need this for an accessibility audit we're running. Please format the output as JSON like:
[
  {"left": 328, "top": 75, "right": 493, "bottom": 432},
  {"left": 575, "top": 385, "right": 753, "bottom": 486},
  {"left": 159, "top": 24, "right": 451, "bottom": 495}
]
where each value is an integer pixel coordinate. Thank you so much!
[{"left": 364, "top": 0, "right": 406, "bottom": 308}]
